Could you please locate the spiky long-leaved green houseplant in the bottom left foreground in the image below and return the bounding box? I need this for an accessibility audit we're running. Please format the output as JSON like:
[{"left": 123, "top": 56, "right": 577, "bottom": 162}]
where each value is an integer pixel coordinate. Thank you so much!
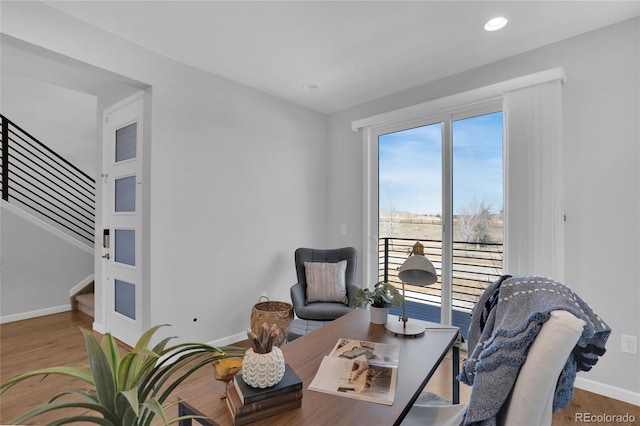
[{"left": 0, "top": 324, "right": 245, "bottom": 426}]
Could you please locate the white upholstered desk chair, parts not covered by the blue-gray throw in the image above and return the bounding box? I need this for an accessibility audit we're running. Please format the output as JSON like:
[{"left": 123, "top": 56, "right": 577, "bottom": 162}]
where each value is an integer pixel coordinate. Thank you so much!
[{"left": 402, "top": 311, "right": 585, "bottom": 426}]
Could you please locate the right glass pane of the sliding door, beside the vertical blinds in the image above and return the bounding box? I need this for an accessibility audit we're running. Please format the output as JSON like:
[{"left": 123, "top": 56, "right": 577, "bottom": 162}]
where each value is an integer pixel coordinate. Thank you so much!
[{"left": 453, "top": 111, "right": 504, "bottom": 314}]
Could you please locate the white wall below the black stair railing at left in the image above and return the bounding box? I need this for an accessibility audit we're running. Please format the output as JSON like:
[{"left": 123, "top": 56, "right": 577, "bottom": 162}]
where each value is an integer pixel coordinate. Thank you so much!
[{"left": 0, "top": 201, "right": 93, "bottom": 322}]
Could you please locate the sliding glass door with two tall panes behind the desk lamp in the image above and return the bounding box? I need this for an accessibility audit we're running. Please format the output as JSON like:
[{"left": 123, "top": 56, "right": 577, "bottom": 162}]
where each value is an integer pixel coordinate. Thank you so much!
[{"left": 369, "top": 105, "right": 503, "bottom": 333}]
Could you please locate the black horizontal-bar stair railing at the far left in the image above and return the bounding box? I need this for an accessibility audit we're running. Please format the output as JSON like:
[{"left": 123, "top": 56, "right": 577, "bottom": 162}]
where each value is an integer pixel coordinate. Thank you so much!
[{"left": 0, "top": 114, "right": 96, "bottom": 245}]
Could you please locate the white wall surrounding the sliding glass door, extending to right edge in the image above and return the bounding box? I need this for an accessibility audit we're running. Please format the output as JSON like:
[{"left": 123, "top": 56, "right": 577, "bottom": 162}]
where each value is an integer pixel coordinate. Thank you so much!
[{"left": 328, "top": 18, "right": 640, "bottom": 404}]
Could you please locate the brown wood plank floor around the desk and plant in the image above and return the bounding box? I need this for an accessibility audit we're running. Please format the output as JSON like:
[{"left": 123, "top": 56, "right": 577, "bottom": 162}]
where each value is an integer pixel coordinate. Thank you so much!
[{"left": 0, "top": 311, "right": 640, "bottom": 426}]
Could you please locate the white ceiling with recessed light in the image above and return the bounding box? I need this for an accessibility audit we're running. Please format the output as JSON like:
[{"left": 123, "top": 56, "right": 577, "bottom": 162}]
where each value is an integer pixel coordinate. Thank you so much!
[{"left": 32, "top": 0, "right": 640, "bottom": 113}]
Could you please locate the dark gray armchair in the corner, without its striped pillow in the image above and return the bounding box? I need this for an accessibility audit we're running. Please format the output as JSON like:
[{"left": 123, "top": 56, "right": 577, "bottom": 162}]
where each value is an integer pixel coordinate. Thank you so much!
[{"left": 291, "top": 247, "right": 358, "bottom": 321}]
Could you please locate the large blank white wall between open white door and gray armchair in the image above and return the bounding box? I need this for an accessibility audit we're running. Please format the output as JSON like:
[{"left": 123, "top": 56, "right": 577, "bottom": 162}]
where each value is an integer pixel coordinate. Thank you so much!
[{"left": 2, "top": 2, "right": 328, "bottom": 341}]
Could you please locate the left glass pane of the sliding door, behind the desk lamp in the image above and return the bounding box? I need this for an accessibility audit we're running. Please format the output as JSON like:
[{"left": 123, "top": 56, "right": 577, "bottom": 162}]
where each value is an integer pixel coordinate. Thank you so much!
[{"left": 378, "top": 123, "right": 442, "bottom": 322}]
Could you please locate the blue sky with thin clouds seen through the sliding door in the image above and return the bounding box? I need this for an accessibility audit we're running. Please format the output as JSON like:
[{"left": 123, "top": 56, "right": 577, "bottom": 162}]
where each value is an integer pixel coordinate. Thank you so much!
[{"left": 378, "top": 112, "right": 503, "bottom": 214}]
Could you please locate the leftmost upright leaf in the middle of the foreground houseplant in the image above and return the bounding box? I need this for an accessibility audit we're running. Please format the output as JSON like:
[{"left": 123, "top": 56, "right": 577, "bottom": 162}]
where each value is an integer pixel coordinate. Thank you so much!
[{"left": 82, "top": 330, "right": 116, "bottom": 412}]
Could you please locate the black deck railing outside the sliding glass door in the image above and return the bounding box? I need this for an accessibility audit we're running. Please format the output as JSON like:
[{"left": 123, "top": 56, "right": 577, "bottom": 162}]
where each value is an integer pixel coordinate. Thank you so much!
[{"left": 378, "top": 238, "right": 503, "bottom": 312}]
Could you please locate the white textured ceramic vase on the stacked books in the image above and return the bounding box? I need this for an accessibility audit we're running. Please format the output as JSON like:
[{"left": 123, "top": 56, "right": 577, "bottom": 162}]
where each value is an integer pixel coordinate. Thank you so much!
[{"left": 242, "top": 346, "right": 284, "bottom": 389}]
